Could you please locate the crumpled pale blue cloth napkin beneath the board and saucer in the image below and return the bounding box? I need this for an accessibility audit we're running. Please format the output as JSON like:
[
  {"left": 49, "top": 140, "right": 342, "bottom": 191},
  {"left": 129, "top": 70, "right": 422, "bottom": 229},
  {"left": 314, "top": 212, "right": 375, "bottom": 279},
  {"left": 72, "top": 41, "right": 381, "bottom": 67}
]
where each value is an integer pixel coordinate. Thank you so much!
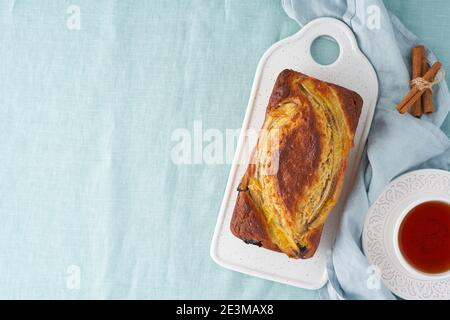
[{"left": 282, "top": 0, "right": 450, "bottom": 299}]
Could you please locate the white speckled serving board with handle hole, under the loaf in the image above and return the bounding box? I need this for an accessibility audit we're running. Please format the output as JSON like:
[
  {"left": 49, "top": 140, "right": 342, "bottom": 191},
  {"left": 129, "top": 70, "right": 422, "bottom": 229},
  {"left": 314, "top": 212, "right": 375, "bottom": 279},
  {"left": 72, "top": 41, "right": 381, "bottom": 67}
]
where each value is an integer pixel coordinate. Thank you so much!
[{"left": 211, "top": 18, "right": 378, "bottom": 289}]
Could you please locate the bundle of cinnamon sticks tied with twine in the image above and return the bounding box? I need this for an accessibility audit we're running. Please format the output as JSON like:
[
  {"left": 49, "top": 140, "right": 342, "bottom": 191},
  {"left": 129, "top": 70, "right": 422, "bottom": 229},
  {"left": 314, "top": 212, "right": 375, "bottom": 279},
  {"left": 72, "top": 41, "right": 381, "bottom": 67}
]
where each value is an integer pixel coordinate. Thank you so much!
[{"left": 397, "top": 46, "right": 445, "bottom": 118}]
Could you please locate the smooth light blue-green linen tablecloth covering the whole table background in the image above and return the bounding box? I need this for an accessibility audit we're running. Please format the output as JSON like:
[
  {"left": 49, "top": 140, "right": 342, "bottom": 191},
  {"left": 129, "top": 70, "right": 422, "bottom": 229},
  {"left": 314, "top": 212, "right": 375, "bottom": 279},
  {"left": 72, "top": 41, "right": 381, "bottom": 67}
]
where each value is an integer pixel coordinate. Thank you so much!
[{"left": 0, "top": 0, "right": 450, "bottom": 299}]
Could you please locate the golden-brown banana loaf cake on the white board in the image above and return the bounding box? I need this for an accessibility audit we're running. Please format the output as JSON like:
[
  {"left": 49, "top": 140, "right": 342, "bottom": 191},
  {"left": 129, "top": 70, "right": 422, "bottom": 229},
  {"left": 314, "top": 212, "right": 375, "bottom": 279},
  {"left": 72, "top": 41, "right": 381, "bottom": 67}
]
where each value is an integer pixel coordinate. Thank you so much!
[{"left": 231, "top": 70, "right": 363, "bottom": 259}]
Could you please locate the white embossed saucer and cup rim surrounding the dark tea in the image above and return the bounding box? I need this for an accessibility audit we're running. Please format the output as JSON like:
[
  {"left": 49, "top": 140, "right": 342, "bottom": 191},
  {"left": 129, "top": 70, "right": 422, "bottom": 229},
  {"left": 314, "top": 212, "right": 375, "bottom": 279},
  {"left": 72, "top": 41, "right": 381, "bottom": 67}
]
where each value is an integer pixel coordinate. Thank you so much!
[{"left": 362, "top": 169, "right": 450, "bottom": 300}]
